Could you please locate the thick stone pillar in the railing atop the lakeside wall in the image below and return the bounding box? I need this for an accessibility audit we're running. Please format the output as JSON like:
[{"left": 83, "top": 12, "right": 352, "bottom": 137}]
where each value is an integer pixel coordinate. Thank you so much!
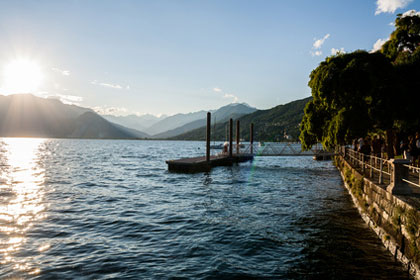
[{"left": 386, "top": 159, "right": 412, "bottom": 194}]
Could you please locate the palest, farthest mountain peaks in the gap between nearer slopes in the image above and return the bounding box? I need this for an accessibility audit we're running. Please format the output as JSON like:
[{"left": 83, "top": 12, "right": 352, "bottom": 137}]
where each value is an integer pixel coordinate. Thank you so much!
[{"left": 102, "top": 114, "right": 167, "bottom": 132}]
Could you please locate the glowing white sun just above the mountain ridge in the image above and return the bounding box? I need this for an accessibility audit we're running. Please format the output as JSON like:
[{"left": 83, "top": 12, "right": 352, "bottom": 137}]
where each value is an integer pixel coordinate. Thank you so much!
[{"left": 1, "top": 58, "right": 44, "bottom": 95}]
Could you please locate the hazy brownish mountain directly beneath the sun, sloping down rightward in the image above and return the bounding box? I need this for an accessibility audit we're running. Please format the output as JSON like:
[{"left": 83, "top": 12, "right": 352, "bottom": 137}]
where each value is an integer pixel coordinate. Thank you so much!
[{"left": 0, "top": 94, "right": 148, "bottom": 138}]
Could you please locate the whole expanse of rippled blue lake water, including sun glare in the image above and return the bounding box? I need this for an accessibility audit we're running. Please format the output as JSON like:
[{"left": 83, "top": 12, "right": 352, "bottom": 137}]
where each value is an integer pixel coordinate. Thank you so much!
[{"left": 0, "top": 139, "right": 407, "bottom": 279}]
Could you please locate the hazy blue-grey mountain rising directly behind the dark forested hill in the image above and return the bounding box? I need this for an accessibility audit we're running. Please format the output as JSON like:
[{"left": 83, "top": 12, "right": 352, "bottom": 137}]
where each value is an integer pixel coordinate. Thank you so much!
[{"left": 153, "top": 103, "right": 257, "bottom": 139}]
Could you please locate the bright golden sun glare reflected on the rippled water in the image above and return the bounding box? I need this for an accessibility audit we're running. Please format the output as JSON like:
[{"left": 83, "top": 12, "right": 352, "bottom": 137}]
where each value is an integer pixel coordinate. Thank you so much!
[{"left": 0, "top": 138, "right": 49, "bottom": 274}]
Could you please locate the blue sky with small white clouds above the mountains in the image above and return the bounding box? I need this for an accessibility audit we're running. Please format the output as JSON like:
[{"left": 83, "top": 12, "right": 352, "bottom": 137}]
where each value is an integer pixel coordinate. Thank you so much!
[{"left": 0, "top": 0, "right": 420, "bottom": 115}]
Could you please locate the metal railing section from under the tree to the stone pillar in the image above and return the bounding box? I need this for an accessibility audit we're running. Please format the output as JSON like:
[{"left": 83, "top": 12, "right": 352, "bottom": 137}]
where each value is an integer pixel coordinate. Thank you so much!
[{"left": 340, "top": 147, "right": 392, "bottom": 184}]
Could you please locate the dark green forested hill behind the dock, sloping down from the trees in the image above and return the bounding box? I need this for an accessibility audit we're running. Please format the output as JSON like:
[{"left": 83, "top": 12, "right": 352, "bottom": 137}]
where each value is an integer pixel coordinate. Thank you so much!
[{"left": 171, "top": 97, "right": 312, "bottom": 141}]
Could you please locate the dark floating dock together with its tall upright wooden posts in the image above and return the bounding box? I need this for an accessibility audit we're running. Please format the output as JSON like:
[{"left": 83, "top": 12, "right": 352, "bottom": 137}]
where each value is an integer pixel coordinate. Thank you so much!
[{"left": 166, "top": 112, "right": 254, "bottom": 173}]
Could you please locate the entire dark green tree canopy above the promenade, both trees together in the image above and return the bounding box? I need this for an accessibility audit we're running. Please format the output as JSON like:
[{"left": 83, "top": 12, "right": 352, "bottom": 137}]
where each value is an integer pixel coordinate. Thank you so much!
[{"left": 300, "top": 12, "right": 420, "bottom": 149}]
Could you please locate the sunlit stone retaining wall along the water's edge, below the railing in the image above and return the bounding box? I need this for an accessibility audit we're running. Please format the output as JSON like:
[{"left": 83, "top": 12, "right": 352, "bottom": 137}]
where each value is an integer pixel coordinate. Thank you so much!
[{"left": 335, "top": 156, "right": 420, "bottom": 279}]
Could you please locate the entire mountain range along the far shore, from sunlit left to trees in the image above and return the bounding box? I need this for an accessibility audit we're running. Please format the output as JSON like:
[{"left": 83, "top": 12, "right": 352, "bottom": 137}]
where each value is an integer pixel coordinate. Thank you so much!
[{"left": 0, "top": 94, "right": 310, "bottom": 141}]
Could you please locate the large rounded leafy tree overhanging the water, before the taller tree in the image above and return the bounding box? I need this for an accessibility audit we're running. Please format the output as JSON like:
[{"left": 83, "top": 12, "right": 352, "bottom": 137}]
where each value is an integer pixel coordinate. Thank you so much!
[{"left": 300, "top": 51, "right": 393, "bottom": 149}]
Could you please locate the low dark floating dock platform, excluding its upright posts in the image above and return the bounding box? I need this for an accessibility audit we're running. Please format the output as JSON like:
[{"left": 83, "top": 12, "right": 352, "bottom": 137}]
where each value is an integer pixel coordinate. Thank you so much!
[{"left": 166, "top": 154, "right": 254, "bottom": 173}]
